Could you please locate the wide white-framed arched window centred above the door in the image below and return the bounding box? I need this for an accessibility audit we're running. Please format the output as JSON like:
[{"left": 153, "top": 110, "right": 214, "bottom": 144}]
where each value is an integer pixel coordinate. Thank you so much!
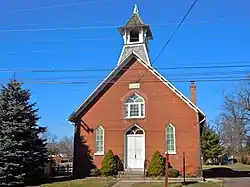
[{"left": 125, "top": 94, "right": 145, "bottom": 118}]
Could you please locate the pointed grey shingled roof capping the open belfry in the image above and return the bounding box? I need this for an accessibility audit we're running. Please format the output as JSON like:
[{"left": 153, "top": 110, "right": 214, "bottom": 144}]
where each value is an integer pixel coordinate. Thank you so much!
[{"left": 119, "top": 4, "right": 153, "bottom": 39}]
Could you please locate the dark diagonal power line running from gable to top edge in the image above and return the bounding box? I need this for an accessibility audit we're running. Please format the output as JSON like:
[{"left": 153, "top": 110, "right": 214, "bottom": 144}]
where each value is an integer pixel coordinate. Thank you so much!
[{"left": 138, "top": 0, "right": 198, "bottom": 82}]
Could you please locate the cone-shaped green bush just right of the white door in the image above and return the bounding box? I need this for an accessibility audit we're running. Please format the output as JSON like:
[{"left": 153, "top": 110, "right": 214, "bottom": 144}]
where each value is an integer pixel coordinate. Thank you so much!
[{"left": 148, "top": 151, "right": 165, "bottom": 177}]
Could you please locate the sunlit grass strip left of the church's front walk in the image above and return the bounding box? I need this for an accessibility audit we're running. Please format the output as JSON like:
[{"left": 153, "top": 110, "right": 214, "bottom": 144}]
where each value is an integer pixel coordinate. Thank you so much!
[{"left": 41, "top": 178, "right": 115, "bottom": 187}]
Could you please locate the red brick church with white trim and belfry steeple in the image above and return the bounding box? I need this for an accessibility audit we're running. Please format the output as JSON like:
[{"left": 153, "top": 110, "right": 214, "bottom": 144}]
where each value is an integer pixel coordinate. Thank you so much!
[{"left": 69, "top": 4, "right": 206, "bottom": 176}]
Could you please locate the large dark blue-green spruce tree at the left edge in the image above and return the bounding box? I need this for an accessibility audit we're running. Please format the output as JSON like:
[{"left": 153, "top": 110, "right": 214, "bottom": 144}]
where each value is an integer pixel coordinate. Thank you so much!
[{"left": 0, "top": 79, "right": 47, "bottom": 186}]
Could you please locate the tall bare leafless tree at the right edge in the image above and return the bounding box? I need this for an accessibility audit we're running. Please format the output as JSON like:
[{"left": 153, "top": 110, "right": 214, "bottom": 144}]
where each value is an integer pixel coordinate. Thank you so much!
[{"left": 217, "top": 81, "right": 250, "bottom": 161}]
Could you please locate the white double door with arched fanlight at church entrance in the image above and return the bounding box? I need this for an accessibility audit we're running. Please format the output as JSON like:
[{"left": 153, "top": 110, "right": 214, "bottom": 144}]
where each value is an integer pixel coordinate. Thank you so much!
[{"left": 124, "top": 125, "right": 145, "bottom": 170}]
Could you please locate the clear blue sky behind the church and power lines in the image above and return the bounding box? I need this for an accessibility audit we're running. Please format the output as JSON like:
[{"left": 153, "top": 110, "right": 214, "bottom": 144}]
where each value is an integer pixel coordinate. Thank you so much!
[{"left": 0, "top": 0, "right": 250, "bottom": 137}]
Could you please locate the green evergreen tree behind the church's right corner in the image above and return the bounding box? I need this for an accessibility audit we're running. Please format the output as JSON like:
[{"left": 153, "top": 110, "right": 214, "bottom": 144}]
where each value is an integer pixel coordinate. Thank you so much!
[{"left": 201, "top": 123, "right": 223, "bottom": 163}]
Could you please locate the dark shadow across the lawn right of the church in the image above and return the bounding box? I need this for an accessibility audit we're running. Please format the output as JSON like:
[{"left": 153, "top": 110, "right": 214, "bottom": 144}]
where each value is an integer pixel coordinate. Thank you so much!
[{"left": 203, "top": 167, "right": 250, "bottom": 178}]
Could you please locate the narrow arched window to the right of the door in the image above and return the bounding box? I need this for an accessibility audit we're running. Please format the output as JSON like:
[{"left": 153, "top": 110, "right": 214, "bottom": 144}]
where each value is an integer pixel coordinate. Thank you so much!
[{"left": 165, "top": 124, "right": 176, "bottom": 154}]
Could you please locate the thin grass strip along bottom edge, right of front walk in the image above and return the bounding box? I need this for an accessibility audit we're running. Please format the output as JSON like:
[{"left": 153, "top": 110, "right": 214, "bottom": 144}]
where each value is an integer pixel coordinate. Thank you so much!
[{"left": 131, "top": 182, "right": 221, "bottom": 187}]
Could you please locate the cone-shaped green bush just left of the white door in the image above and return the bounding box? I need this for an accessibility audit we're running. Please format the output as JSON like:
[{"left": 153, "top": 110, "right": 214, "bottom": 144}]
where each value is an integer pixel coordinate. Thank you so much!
[{"left": 100, "top": 150, "right": 117, "bottom": 176}]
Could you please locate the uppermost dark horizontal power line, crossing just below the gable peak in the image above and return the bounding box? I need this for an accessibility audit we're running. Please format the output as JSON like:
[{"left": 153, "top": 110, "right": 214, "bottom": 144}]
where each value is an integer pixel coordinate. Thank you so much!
[{"left": 0, "top": 62, "right": 250, "bottom": 73}]
